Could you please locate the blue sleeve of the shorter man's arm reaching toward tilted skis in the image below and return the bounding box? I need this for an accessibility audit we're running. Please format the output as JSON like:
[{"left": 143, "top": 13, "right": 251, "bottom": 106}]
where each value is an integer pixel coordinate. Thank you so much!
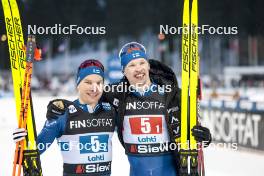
[{"left": 37, "top": 113, "right": 67, "bottom": 154}]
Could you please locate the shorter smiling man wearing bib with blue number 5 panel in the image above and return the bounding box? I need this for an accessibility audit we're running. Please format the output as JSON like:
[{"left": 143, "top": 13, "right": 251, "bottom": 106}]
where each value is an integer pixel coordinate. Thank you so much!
[{"left": 14, "top": 60, "right": 116, "bottom": 176}]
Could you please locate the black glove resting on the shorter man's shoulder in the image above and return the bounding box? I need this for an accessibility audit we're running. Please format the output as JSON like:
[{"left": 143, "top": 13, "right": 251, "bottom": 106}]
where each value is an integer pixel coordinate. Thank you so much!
[{"left": 46, "top": 99, "right": 70, "bottom": 120}]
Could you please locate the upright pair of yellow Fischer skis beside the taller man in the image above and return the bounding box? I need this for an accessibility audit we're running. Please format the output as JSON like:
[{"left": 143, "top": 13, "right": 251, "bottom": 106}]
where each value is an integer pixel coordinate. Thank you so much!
[{"left": 180, "top": 0, "right": 204, "bottom": 176}]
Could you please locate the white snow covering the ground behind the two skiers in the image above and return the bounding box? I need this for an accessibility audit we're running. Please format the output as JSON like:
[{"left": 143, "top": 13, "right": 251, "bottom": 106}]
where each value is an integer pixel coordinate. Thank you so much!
[{"left": 0, "top": 96, "right": 264, "bottom": 176}]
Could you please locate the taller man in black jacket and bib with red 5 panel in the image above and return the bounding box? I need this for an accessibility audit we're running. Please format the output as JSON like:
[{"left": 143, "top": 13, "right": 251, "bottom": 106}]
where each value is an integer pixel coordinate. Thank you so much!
[{"left": 102, "top": 42, "right": 211, "bottom": 176}]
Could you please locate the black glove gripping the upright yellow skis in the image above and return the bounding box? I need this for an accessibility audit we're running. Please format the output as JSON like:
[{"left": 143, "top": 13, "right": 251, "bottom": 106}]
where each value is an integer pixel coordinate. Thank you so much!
[{"left": 192, "top": 125, "right": 212, "bottom": 147}]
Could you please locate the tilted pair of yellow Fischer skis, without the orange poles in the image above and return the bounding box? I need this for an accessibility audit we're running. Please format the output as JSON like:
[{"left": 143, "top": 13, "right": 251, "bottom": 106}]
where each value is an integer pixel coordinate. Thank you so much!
[{"left": 2, "top": 0, "right": 42, "bottom": 175}]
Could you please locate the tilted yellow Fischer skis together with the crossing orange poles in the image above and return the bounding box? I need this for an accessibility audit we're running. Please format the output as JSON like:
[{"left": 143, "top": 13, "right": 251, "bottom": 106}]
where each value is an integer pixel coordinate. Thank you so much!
[{"left": 2, "top": 0, "right": 42, "bottom": 176}]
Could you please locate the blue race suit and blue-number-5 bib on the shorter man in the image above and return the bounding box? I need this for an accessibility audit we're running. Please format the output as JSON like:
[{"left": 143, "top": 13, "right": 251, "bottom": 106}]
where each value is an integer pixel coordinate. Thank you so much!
[{"left": 37, "top": 100, "right": 115, "bottom": 176}]
